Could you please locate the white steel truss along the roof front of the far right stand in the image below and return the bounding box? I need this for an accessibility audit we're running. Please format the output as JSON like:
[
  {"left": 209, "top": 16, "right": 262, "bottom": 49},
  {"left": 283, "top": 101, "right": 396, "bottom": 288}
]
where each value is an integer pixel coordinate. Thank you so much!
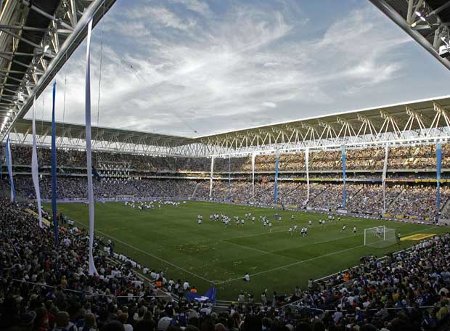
[{"left": 202, "top": 102, "right": 450, "bottom": 157}]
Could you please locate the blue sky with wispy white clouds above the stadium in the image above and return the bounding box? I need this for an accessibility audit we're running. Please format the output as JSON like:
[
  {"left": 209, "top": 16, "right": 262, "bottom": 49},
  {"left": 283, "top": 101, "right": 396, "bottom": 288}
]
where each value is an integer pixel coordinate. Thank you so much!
[{"left": 27, "top": 0, "right": 450, "bottom": 137}]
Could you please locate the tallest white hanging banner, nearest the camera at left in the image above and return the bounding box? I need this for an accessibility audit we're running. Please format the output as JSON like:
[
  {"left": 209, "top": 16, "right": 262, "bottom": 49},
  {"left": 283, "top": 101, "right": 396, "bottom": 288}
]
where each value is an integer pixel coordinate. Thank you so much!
[{"left": 85, "top": 19, "right": 98, "bottom": 276}]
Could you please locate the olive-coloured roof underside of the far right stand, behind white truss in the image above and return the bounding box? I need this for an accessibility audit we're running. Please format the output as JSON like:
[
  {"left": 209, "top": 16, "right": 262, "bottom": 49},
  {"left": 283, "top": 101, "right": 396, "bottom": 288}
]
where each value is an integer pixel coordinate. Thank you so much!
[{"left": 199, "top": 97, "right": 450, "bottom": 145}]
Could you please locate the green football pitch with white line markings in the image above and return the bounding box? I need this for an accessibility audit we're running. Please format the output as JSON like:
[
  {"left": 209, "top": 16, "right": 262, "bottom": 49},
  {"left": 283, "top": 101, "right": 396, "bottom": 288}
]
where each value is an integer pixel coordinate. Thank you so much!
[{"left": 54, "top": 202, "right": 448, "bottom": 300}]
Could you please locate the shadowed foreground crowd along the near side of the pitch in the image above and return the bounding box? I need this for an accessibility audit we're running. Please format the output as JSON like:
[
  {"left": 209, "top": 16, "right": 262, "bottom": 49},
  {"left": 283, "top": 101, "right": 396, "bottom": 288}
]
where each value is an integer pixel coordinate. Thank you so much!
[{"left": 0, "top": 200, "right": 450, "bottom": 331}]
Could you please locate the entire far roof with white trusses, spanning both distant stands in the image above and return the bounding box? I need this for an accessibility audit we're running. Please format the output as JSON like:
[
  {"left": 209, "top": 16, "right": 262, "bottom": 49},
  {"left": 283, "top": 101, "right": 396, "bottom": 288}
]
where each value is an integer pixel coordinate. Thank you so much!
[{"left": 11, "top": 96, "right": 450, "bottom": 156}]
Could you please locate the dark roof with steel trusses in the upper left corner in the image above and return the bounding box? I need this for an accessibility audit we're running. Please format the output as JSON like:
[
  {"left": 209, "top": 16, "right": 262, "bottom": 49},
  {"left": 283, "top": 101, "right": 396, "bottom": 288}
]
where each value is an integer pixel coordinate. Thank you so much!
[{"left": 0, "top": 0, "right": 115, "bottom": 136}]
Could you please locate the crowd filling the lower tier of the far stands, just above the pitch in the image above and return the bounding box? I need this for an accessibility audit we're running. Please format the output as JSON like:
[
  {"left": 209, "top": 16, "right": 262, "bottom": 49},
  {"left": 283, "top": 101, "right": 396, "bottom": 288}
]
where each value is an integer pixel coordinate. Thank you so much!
[{"left": 9, "top": 175, "right": 450, "bottom": 221}]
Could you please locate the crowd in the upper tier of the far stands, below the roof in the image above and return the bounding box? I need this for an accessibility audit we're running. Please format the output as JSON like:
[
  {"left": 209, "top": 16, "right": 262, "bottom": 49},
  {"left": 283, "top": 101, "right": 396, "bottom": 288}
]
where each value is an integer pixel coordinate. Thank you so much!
[{"left": 7, "top": 144, "right": 450, "bottom": 173}]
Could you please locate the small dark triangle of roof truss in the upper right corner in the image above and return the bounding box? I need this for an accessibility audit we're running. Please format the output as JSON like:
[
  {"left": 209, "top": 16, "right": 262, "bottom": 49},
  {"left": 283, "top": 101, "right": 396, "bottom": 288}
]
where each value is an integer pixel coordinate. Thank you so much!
[{"left": 370, "top": 0, "right": 450, "bottom": 69}]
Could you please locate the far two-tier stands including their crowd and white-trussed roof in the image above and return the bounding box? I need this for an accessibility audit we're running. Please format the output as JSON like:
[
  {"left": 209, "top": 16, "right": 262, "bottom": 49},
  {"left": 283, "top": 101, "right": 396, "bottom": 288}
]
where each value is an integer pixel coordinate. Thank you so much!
[{"left": 4, "top": 97, "right": 450, "bottom": 221}]
